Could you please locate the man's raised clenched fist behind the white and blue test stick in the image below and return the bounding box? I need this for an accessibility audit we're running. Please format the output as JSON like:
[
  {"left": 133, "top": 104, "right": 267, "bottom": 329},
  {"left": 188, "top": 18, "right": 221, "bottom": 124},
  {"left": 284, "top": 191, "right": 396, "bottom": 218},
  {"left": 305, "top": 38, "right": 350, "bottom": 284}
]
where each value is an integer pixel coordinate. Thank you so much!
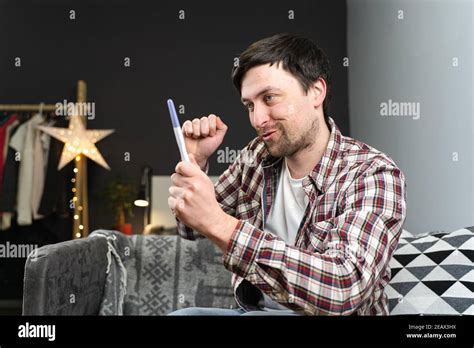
[{"left": 182, "top": 114, "right": 227, "bottom": 170}]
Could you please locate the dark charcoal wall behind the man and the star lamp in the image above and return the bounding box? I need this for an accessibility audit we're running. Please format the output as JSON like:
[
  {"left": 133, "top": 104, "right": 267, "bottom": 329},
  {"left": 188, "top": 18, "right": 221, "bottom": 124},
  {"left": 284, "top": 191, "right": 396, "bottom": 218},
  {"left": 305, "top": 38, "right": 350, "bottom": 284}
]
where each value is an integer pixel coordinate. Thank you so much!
[{"left": 0, "top": 0, "right": 349, "bottom": 237}]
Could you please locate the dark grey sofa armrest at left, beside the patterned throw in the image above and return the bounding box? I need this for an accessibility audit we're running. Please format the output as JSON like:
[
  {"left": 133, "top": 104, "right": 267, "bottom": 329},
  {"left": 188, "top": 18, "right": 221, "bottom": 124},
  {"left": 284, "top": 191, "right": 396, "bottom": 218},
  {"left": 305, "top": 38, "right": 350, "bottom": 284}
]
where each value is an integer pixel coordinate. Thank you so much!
[{"left": 23, "top": 238, "right": 108, "bottom": 315}]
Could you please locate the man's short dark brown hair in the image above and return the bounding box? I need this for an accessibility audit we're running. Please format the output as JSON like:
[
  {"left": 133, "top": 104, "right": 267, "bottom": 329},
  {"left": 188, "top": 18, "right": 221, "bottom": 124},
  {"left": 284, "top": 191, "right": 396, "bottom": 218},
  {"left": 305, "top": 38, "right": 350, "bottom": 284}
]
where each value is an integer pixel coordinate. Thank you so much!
[{"left": 232, "top": 33, "right": 331, "bottom": 126}]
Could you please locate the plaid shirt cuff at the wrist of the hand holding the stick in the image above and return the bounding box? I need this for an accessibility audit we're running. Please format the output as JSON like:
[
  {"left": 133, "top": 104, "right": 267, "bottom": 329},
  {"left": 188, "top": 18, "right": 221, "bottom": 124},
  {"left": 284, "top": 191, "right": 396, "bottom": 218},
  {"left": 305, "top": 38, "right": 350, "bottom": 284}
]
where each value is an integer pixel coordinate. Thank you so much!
[{"left": 222, "top": 220, "right": 265, "bottom": 278}]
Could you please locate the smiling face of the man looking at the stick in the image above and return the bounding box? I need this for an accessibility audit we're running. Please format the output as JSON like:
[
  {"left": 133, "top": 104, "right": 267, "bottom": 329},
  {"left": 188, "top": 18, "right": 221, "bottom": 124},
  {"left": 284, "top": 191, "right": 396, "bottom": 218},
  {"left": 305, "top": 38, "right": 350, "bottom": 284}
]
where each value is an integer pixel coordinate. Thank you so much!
[{"left": 241, "top": 64, "right": 319, "bottom": 157}]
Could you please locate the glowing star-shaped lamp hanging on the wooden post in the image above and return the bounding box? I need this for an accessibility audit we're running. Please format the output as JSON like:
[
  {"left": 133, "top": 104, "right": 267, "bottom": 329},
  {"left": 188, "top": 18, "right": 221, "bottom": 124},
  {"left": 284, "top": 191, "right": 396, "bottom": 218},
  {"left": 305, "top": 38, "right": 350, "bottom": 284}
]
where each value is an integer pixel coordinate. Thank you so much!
[{"left": 38, "top": 116, "right": 114, "bottom": 170}]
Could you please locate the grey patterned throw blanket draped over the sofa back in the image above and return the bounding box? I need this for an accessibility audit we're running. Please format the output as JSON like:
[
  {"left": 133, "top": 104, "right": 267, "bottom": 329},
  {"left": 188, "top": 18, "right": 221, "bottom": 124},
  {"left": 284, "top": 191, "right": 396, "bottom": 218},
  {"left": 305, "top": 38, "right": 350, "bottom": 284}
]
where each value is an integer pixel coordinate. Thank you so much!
[{"left": 89, "top": 230, "right": 236, "bottom": 315}]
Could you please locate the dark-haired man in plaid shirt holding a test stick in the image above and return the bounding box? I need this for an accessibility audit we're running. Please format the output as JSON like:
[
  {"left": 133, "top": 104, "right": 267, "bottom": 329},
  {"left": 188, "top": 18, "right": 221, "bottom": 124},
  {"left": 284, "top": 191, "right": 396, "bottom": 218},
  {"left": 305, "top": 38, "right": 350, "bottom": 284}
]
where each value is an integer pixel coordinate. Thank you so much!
[{"left": 168, "top": 34, "right": 406, "bottom": 315}]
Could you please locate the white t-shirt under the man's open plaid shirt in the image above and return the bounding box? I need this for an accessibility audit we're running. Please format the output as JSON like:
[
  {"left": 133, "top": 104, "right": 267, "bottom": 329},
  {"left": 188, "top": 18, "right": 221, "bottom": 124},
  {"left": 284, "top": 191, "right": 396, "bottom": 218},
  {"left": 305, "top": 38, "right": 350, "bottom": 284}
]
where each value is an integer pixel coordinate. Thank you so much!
[{"left": 259, "top": 159, "right": 309, "bottom": 311}]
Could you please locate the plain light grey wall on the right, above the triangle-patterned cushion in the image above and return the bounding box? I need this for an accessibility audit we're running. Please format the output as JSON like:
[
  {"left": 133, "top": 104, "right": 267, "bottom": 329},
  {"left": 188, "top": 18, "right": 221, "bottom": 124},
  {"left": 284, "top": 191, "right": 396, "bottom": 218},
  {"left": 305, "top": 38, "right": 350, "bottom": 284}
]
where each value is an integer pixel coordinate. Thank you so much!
[{"left": 347, "top": 0, "right": 474, "bottom": 234}]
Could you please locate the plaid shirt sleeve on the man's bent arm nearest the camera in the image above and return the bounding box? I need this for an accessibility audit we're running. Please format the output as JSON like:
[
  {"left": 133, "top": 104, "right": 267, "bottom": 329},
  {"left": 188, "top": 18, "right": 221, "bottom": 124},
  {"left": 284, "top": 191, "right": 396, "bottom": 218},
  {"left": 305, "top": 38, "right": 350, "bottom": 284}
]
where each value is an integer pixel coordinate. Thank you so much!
[{"left": 223, "top": 160, "right": 406, "bottom": 315}]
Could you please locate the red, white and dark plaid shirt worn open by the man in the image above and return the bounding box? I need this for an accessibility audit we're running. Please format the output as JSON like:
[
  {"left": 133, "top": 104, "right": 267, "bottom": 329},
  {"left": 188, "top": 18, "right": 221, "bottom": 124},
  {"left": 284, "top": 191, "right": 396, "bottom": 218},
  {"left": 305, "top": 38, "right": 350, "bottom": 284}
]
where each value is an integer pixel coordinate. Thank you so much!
[{"left": 178, "top": 119, "right": 406, "bottom": 315}]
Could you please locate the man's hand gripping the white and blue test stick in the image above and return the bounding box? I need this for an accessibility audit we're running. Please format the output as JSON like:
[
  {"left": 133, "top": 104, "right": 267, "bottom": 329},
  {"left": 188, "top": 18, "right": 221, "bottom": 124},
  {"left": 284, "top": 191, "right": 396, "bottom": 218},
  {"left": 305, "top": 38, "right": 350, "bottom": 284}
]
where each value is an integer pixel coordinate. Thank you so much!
[{"left": 168, "top": 154, "right": 238, "bottom": 252}]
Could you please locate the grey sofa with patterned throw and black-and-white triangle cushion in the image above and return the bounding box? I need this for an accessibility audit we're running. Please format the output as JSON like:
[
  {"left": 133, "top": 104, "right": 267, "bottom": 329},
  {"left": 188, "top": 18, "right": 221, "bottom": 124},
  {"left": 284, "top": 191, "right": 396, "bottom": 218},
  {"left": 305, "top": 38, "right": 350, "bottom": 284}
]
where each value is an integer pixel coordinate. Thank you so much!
[{"left": 23, "top": 227, "right": 474, "bottom": 315}]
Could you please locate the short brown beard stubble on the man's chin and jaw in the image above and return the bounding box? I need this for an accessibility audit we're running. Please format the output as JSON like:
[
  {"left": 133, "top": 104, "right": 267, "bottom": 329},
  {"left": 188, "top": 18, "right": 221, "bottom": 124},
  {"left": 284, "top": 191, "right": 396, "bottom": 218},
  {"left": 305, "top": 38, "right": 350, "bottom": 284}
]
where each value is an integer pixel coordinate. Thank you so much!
[{"left": 264, "top": 119, "right": 319, "bottom": 157}]
